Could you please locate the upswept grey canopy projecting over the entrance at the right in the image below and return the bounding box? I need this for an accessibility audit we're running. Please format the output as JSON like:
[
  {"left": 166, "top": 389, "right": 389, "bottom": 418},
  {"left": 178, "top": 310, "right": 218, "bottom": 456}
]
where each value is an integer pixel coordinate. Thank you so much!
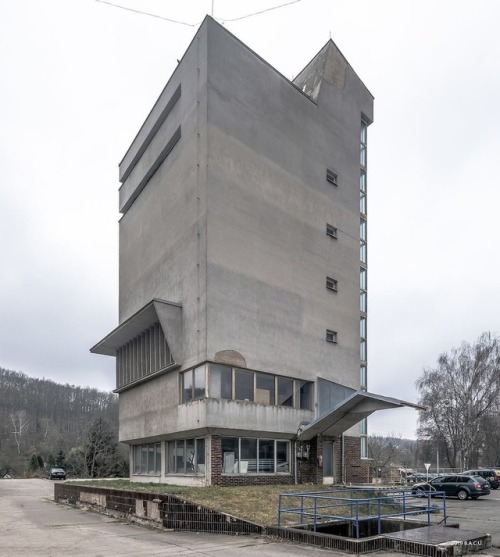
[{"left": 297, "top": 391, "right": 424, "bottom": 441}]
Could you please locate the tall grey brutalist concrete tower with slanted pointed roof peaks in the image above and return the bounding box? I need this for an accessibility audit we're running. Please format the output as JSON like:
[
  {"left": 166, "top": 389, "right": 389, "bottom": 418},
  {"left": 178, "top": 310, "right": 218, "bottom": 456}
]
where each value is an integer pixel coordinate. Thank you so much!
[{"left": 92, "top": 17, "right": 414, "bottom": 485}]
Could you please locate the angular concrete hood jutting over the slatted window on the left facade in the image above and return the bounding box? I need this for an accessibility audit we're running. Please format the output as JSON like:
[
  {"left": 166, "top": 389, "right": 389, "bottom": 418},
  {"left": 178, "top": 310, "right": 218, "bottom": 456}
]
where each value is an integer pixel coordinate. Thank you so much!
[{"left": 90, "top": 298, "right": 182, "bottom": 362}]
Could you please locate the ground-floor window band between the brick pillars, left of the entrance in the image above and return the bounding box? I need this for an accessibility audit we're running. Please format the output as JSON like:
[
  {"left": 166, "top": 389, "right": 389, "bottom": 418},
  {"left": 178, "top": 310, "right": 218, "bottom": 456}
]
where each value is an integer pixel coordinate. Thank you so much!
[{"left": 222, "top": 437, "right": 290, "bottom": 474}]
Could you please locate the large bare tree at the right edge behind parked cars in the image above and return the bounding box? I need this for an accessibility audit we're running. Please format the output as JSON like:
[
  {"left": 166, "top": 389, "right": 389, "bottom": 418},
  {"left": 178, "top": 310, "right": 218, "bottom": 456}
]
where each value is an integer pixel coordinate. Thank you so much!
[{"left": 416, "top": 332, "right": 500, "bottom": 468}]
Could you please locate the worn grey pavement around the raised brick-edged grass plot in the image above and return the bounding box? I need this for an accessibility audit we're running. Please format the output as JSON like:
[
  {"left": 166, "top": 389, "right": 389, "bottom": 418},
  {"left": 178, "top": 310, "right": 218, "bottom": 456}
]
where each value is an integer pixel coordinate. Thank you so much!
[{"left": 0, "top": 479, "right": 500, "bottom": 557}]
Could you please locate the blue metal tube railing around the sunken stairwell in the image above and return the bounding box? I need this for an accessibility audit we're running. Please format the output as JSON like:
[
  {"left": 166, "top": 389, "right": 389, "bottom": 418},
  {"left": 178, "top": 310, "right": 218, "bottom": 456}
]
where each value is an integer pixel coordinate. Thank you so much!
[{"left": 278, "top": 488, "right": 447, "bottom": 539}]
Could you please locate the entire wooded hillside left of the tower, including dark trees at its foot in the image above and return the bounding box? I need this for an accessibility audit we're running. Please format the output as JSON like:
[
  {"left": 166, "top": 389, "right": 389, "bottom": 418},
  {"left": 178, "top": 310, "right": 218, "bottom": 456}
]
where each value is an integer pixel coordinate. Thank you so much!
[{"left": 0, "top": 368, "right": 124, "bottom": 476}]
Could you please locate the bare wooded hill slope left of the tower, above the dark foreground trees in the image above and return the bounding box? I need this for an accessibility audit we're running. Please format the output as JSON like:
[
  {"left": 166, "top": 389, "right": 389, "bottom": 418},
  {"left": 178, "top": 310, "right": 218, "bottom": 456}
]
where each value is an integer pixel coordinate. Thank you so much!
[{"left": 0, "top": 367, "right": 118, "bottom": 473}]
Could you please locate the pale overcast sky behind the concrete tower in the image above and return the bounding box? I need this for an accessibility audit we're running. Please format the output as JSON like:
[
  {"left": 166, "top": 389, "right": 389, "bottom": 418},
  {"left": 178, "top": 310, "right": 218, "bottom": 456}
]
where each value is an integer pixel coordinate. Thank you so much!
[{"left": 0, "top": 0, "right": 500, "bottom": 437}]
